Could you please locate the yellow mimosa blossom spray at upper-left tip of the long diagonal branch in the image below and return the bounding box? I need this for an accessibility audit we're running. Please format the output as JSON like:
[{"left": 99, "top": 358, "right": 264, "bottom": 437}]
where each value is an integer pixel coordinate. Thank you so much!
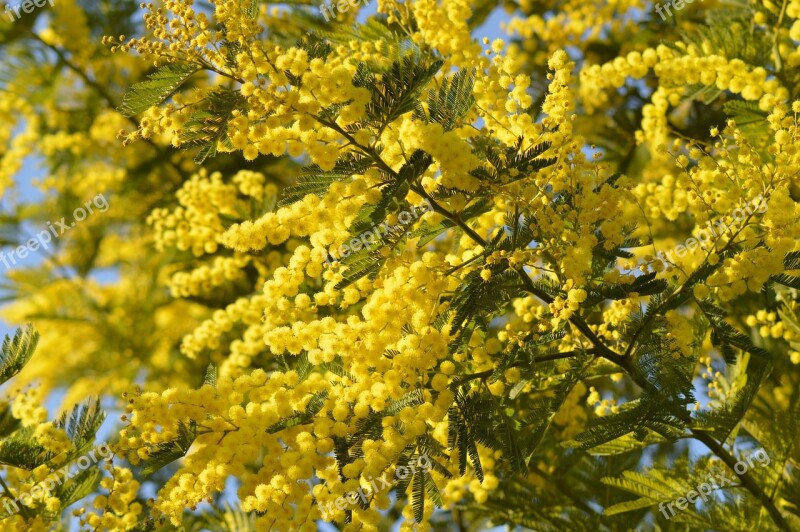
[{"left": 106, "top": 0, "right": 380, "bottom": 169}]
